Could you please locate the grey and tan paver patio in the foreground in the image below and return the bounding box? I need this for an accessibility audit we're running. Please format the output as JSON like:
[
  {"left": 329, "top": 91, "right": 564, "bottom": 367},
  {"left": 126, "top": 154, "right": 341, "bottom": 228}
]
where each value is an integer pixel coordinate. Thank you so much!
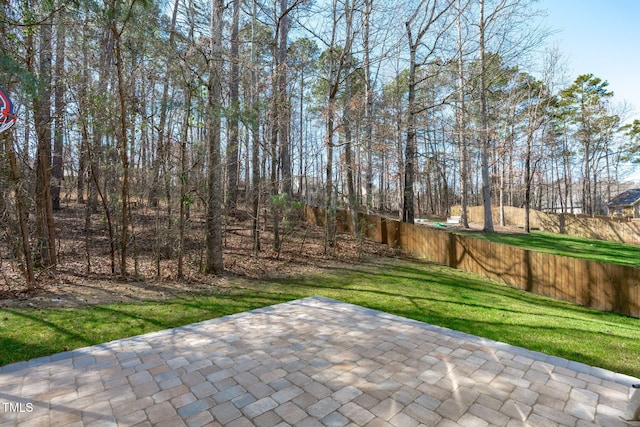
[{"left": 0, "top": 297, "right": 640, "bottom": 427}]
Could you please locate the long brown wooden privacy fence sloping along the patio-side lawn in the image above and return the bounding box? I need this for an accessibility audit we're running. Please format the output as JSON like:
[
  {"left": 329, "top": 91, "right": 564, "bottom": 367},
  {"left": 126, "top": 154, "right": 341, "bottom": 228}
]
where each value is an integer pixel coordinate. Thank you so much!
[{"left": 305, "top": 206, "right": 640, "bottom": 318}]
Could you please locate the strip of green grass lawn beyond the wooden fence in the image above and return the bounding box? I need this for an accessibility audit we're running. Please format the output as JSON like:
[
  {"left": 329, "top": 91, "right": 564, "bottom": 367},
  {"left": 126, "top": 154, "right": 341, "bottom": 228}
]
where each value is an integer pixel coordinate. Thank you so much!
[{"left": 456, "top": 231, "right": 640, "bottom": 267}]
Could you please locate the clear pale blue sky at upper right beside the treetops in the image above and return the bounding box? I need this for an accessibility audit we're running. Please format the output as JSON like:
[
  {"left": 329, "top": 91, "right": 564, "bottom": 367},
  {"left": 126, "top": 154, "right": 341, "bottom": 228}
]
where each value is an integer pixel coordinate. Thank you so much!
[{"left": 538, "top": 0, "right": 640, "bottom": 119}]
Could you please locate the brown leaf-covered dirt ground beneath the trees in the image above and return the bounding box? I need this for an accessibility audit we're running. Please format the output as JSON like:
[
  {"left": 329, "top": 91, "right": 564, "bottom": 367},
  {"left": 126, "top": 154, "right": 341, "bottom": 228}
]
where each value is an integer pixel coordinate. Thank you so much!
[{"left": 0, "top": 204, "right": 399, "bottom": 308}]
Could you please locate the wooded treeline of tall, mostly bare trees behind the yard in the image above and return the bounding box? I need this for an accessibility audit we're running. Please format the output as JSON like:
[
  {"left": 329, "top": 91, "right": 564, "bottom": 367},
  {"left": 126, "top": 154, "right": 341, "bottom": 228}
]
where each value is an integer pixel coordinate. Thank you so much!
[{"left": 0, "top": 0, "right": 640, "bottom": 283}]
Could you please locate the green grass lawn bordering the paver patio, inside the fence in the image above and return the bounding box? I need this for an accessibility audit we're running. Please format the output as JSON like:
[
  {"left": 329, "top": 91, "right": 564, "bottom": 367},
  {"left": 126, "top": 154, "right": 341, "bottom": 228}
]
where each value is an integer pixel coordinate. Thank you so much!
[{"left": 0, "top": 258, "right": 640, "bottom": 377}]
